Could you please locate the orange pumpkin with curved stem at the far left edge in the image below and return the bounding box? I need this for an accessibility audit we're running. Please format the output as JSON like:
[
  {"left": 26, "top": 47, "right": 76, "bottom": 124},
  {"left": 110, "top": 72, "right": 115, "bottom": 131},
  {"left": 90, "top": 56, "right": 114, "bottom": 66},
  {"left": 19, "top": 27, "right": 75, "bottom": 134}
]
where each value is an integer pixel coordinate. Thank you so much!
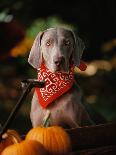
[{"left": 0, "top": 130, "right": 21, "bottom": 155}]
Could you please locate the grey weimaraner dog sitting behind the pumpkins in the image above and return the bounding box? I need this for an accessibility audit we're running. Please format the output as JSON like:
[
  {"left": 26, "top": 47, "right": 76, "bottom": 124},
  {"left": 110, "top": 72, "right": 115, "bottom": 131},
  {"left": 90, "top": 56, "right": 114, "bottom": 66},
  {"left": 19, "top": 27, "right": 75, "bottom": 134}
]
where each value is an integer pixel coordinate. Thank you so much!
[{"left": 28, "top": 28, "right": 92, "bottom": 128}]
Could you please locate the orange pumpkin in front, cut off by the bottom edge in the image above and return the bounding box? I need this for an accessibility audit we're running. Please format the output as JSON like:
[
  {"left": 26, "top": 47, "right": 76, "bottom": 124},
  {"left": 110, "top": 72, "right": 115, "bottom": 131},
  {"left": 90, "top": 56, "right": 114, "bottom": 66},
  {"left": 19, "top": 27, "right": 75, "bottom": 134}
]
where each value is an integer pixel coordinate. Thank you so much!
[{"left": 1, "top": 140, "right": 47, "bottom": 155}]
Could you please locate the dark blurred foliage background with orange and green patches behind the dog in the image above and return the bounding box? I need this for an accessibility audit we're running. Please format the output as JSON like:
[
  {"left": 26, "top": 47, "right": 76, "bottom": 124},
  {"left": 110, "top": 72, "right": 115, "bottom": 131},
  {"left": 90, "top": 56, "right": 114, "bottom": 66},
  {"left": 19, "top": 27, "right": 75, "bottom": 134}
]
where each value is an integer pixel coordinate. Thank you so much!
[{"left": 0, "top": 0, "right": 116, "bottom": 134}]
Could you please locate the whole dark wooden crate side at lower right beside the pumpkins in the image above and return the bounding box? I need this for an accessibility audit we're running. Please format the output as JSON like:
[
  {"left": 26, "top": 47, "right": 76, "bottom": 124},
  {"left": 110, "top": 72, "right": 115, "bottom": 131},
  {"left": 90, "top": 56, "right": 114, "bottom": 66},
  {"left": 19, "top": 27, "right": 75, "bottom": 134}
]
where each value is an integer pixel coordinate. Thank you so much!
[{"left": 66, "top": 123, "right": 116, "bottom": 155}]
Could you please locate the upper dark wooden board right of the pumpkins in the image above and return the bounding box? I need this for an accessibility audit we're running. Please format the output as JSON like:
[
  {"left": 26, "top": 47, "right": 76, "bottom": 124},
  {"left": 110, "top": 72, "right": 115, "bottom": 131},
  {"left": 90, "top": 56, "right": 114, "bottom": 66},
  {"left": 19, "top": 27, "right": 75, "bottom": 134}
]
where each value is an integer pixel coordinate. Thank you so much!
[{"left": 66, "top": 123, "right": 116, "bottom": 150}]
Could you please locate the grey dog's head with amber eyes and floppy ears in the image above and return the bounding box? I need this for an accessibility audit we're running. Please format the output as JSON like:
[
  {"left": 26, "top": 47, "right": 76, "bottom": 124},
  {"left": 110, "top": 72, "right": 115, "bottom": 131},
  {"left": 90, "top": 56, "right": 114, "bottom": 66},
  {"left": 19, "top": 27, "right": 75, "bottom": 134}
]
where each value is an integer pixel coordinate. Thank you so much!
[{"left": 28, "top": 28, "right": 84, "bottom": 72}]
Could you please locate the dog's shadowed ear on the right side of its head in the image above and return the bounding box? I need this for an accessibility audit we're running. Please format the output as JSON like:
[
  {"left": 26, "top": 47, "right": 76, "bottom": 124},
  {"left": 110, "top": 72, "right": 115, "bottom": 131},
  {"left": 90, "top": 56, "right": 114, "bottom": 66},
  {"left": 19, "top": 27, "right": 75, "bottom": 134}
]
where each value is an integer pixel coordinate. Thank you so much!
[{"left": 73, "top": 35, "right": 85, "bottom": 66}]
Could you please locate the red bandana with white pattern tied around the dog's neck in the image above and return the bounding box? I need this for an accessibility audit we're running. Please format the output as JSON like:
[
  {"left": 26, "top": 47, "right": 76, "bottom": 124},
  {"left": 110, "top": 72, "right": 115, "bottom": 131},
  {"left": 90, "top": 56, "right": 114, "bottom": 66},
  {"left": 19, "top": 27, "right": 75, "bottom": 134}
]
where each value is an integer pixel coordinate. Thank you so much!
[{"left": 35, "top": 62, "right": 86, "bottom": 108}]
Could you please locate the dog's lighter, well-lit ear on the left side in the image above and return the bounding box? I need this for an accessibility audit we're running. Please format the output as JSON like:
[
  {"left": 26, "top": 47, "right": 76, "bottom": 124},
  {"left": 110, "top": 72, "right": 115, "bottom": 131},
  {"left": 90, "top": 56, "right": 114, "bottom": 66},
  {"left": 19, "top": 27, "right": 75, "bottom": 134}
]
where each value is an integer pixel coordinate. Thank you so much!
[{"left": 28, "top": 32, "right": 44, "bottom": 69}]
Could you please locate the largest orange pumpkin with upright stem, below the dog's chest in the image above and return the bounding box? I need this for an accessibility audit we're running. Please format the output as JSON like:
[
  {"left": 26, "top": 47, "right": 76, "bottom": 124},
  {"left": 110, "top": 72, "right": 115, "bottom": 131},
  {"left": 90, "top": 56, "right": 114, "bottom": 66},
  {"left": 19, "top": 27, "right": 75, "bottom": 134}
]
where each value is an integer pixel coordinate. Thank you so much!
[{"left": 26, "top": 126, "right": 71, "bottom": 155}]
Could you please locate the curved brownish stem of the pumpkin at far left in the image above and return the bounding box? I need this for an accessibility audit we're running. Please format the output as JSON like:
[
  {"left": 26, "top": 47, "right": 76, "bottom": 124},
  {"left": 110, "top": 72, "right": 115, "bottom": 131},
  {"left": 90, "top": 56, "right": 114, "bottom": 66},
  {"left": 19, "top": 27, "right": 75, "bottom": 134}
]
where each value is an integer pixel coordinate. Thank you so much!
[{"left": 2, "top": 130, "right": 21, "bottom": 144}]
